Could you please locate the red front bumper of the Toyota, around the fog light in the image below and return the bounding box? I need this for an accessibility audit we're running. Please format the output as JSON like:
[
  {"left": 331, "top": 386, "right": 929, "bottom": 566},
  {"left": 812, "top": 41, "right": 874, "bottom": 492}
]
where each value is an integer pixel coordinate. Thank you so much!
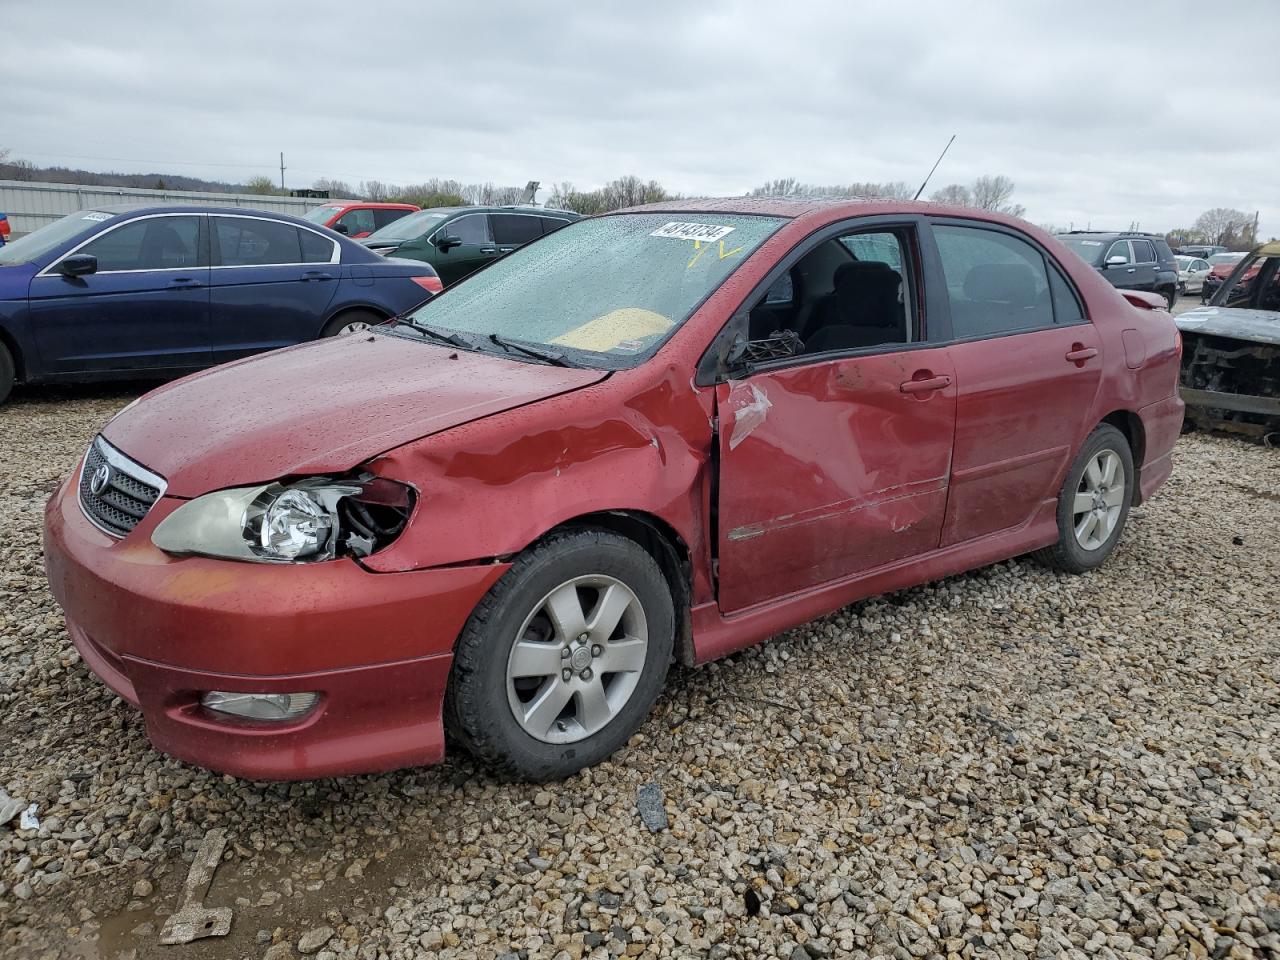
[{"left": 45, "top": 473, "right": 508, "bottom": 780}]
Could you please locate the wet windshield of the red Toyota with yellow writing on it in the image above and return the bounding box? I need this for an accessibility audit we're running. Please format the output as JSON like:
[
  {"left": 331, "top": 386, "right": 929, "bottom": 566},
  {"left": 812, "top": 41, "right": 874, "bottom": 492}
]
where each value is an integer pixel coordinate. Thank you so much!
[{"left": 399, "top": 214, "right": 786, "bottom": 367}]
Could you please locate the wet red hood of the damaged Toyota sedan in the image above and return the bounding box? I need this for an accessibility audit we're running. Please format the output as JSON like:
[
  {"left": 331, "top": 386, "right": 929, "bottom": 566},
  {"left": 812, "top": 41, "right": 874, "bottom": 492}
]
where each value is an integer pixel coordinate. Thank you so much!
[{"left": 102, "top": 334, "right": 608, "bottom": 497}]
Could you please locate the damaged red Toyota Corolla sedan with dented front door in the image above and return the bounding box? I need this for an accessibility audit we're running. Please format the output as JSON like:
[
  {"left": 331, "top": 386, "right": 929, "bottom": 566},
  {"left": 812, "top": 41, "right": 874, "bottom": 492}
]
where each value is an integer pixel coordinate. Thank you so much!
[{"left": 46, "top": 200, "right": 1183, "bottom": 780}]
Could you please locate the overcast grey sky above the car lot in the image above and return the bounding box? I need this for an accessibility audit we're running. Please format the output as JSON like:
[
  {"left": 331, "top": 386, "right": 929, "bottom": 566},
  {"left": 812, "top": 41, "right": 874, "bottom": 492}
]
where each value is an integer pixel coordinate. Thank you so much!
[{"left": 0, "top": 0, "right": 1280, "bottom": 236}]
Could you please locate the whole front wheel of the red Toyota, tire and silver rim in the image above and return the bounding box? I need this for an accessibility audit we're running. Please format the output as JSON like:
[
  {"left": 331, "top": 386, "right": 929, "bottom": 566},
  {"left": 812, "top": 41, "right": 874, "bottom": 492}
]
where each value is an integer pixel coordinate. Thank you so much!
[{"left": 445, "top": 530, "right": 676, "bottom": 781}]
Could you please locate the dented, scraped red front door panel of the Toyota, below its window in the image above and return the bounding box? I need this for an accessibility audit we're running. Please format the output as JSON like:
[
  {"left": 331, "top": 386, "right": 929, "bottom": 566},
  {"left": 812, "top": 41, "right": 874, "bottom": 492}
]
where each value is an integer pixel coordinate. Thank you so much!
[{"left": 716, "top": 347, "right": 956, "bottom": 613}]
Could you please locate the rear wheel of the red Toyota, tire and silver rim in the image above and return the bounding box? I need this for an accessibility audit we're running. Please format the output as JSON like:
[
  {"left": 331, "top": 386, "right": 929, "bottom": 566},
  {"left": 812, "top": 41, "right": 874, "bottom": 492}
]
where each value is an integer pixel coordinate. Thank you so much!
[{"left": 1033, "top": 424, "right": 1137, "bottom": 573}]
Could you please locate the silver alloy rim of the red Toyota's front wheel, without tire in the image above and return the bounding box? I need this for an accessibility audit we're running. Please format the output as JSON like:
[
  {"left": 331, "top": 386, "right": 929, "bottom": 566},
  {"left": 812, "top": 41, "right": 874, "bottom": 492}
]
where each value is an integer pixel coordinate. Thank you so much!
[{"left": 507, "top": 575, "right": 649, "bottom": 744}]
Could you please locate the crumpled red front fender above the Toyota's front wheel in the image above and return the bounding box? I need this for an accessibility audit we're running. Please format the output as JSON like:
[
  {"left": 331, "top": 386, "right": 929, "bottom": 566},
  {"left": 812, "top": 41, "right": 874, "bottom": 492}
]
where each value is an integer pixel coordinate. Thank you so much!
[{"left": 364, "top": 367, "right": 712, "bottom": 599}]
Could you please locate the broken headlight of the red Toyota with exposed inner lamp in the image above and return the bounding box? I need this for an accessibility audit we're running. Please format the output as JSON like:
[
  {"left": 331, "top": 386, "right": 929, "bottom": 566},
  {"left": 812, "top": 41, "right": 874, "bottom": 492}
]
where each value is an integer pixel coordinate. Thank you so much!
[{"left": 151, "top": 474, "right": 413, "bottom": 563}]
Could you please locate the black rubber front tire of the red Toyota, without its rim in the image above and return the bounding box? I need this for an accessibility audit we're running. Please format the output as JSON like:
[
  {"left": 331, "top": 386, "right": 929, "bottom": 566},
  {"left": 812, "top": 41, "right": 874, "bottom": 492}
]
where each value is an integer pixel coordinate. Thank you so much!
[{"left": 444, "top": 530, "right": 676, "bottom": 781}]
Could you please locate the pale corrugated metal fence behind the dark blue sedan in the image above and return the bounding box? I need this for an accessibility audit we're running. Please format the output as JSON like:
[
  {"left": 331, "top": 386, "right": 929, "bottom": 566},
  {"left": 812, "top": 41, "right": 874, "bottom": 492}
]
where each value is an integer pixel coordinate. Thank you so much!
[{"left": 0, "top": 180, "right": 324, "bottom": 238}]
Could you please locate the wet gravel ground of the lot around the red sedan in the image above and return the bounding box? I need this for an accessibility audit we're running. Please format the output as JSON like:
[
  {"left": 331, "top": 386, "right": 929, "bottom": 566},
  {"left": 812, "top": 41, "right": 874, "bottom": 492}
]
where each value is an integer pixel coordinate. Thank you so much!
[{"left": 0, "top": 390, "right": 1280, "bottom": 960}]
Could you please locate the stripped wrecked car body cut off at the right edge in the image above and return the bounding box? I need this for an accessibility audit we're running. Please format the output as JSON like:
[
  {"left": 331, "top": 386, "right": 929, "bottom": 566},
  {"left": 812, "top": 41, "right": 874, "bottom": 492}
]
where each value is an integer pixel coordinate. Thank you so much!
[{"left": 1178, "top": 242, "right": 1280, "bottom": 439}]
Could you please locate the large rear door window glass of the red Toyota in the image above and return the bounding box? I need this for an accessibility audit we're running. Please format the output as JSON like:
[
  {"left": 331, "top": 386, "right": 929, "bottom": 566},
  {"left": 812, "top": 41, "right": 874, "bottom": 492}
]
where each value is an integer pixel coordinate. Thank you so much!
[{"left": 933, "top": 227, "right": 1053, "bottom": 339}]
